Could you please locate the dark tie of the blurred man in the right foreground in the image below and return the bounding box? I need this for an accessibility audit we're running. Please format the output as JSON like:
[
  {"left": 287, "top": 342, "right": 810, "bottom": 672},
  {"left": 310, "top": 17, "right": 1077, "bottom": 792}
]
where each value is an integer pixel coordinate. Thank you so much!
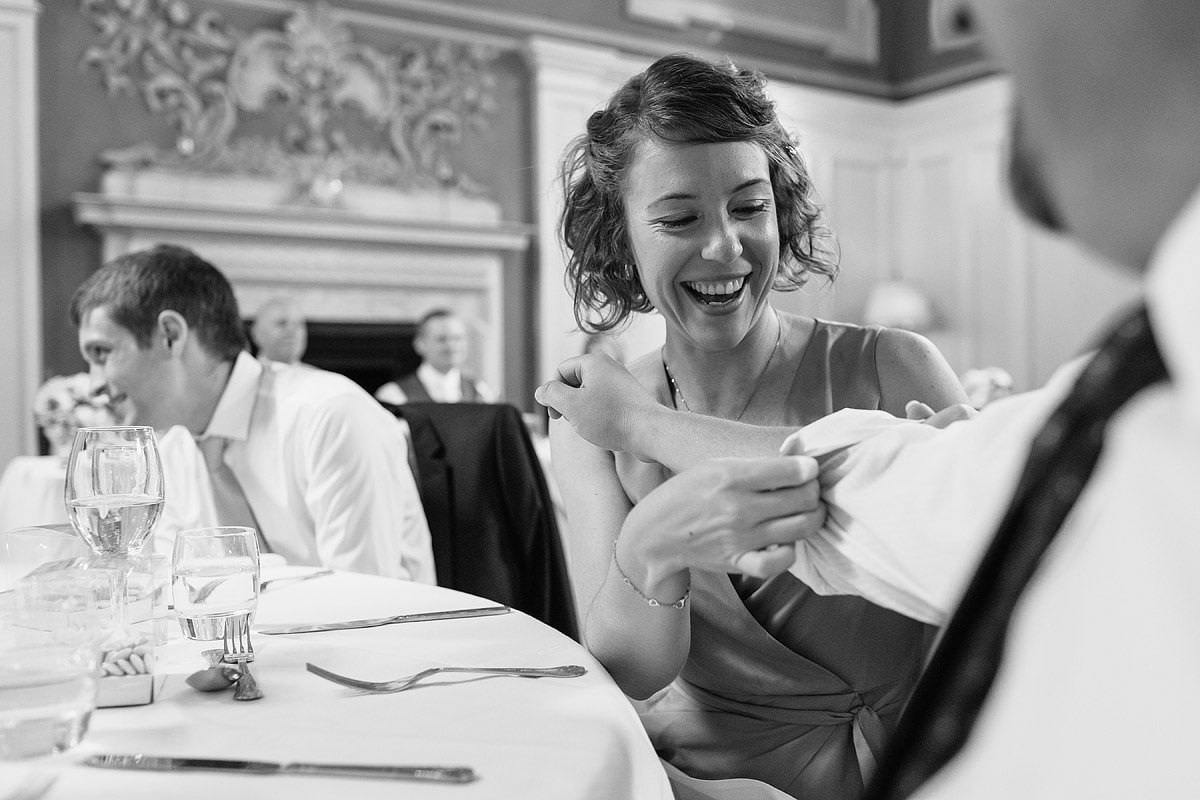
[{"left": 866, "top": 307, "right": 1168, "bottom": 800}]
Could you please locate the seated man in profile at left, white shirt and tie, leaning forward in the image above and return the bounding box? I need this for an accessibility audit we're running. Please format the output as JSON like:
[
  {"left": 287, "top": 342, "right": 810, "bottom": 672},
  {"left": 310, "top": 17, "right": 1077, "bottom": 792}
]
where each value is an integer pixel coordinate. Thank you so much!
[{"left": 71, "top": 245, "right": 434, "bottom": 583}]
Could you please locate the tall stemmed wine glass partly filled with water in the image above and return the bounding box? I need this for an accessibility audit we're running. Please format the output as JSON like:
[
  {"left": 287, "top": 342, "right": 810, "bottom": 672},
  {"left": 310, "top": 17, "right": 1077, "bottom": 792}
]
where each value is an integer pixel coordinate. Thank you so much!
[{"left": 65, "top": 426, "right": 163, "bottom": 624}]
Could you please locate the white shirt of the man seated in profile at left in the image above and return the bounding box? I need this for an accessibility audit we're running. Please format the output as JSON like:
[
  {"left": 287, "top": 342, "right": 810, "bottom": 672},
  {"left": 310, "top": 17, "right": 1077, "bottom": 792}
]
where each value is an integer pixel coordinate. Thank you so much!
[{"left": 155, "top": 353, "right": 436, "bottom": 583}]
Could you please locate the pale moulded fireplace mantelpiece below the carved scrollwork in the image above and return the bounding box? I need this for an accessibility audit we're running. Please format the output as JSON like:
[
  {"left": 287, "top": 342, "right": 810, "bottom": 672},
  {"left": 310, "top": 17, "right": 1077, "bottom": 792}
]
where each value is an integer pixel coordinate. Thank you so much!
[{"left": 74, "top": 169, "right": 533, "bottom": 391}]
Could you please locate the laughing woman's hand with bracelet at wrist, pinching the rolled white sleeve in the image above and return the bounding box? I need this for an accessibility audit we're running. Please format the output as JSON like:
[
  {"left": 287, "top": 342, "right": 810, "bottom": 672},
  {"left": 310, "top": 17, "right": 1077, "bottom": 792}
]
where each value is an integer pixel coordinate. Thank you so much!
[{"left": 617, "top": 456, "right": 824, "bottom": 597}]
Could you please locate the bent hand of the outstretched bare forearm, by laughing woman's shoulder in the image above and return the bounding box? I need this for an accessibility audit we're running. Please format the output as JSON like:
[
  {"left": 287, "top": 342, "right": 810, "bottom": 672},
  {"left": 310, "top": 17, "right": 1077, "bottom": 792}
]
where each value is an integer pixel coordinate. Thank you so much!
[{"left": 534, "top": 353, "right": 664, "bottom": 452}]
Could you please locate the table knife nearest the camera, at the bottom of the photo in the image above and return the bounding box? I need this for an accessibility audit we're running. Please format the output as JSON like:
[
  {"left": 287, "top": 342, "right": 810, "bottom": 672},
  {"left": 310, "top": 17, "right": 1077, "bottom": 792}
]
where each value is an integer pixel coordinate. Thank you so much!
[{"left": 84, "top": 753, "right": 476, "bottom": 783}]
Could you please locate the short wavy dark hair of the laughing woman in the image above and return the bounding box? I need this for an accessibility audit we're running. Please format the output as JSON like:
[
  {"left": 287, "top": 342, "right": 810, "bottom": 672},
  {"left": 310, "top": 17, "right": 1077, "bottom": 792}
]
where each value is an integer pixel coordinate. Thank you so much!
[{"left": 559, "top": 54, "right": 838, "bottom": 332}]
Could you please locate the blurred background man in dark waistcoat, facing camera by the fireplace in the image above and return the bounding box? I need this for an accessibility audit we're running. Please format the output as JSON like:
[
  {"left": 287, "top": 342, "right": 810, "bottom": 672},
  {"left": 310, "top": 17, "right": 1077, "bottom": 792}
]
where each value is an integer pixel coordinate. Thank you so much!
[{"left": 376, "top": 308, "right": 497, "bottom": 405}]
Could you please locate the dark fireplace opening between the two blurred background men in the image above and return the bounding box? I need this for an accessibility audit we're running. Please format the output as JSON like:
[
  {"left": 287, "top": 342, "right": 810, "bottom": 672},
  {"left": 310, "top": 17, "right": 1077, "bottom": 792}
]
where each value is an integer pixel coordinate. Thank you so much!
[{"left": 246, "top": 320, "right": 421, "bottom": 393}]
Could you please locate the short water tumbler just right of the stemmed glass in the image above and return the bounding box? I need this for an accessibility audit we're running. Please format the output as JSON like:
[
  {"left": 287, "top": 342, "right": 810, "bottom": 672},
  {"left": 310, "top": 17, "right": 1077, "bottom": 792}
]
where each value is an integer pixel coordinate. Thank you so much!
[{"left": 172, "top": 527, "right": 259, "bottom": 642}]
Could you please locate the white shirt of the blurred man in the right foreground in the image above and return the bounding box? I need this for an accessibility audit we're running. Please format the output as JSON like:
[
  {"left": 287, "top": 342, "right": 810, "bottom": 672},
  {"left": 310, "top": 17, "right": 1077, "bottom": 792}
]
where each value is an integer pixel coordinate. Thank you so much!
[{"left": 793, "top": 184, "right": 1200, "bottom": 800}]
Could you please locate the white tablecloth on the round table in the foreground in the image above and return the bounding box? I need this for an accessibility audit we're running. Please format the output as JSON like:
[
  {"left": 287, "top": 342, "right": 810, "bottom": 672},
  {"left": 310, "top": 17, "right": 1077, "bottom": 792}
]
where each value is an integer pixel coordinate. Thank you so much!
[{"left": 0, "top": 566, "right": 672, "bottom": 800}]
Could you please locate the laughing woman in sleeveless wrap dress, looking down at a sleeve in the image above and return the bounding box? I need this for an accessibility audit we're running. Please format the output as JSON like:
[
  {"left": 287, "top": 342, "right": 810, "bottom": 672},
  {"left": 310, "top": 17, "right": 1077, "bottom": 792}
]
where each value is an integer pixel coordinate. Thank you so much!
[{"left": 539, "top": 55, "right": 966, "bottom": 800}]
